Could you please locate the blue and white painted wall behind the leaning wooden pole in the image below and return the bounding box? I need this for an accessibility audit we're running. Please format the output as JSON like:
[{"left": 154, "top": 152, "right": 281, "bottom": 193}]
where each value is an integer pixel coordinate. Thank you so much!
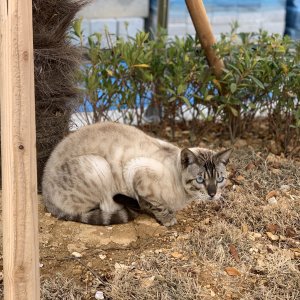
[{"left": 150, "top": 0, "right": 288, "bottom": 36}]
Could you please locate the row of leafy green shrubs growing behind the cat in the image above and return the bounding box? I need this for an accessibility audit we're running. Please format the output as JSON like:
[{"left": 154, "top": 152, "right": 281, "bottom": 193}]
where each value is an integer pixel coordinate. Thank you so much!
[{"left": 73, "top": 20, "right": 300, "bottom": 152}]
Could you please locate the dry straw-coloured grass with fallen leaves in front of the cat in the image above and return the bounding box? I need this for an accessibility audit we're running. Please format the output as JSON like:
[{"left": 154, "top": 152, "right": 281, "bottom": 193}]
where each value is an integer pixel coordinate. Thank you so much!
[{"left": 0, "top": 150, "right": 300, "bottom": 300}]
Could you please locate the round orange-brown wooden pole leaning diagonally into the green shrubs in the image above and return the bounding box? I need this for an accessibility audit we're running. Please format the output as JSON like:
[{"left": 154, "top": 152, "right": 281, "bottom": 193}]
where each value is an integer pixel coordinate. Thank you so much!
[{"left": 185, "top": 0, "right": 224, "bottom": 77}]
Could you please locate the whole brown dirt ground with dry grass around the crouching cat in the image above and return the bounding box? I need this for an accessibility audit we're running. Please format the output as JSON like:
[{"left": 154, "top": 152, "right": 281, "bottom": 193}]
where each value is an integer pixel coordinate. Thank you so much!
[{"left": 0, "top": 125, "right": 300, "bottom": 300}]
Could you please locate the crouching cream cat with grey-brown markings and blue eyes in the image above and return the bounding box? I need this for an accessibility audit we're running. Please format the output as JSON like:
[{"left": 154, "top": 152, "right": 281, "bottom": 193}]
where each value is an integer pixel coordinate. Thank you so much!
[{"left": 42, "top": 122, "right": 231, "bottom": 226}]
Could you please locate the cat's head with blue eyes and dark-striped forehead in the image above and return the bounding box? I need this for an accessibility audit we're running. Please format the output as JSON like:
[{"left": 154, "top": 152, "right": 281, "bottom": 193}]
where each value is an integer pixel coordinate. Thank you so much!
[{"left": 180, "top": 148, "right": 232, "bottom": 200}]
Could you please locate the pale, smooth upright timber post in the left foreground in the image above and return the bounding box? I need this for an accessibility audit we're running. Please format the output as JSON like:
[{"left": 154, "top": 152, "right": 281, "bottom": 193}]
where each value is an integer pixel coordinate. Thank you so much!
[{"left": 0, "top": 0, "right": 40, "bottom": 300}]
